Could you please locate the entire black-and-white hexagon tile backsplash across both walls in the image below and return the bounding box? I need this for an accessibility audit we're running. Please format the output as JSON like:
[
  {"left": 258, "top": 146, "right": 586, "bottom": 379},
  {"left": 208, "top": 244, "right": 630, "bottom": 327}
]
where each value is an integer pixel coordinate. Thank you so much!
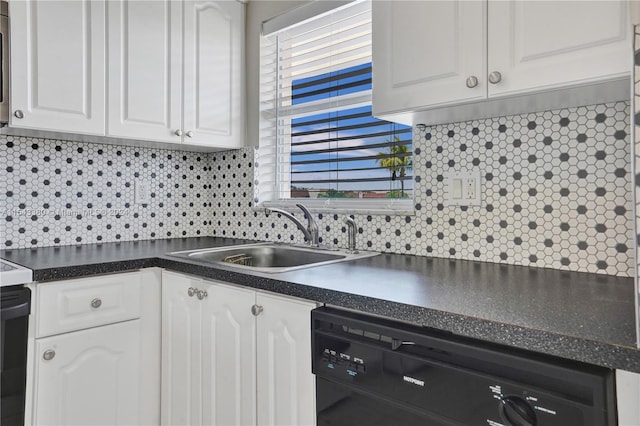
[{"left": 0, "top": 102, "right": 634, "bottom": 276}]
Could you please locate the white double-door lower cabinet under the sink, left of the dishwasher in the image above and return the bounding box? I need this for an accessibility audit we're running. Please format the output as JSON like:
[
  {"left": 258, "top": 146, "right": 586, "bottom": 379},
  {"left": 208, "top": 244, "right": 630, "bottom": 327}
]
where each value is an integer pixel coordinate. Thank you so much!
[{"left": 161, "top": 271, "right": 316, "bottom": 426}]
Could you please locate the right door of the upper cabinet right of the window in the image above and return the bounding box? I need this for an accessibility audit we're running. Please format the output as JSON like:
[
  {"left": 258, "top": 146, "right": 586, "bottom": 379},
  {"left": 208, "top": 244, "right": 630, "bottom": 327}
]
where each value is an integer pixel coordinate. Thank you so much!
[{"left": 488, "top": 0, "right": 632, "bottom": 97}]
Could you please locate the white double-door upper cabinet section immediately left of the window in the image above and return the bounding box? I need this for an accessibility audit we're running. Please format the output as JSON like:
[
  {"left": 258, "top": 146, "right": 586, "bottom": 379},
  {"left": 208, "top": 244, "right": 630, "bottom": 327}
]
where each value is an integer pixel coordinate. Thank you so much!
[{"left": 107, "top": 0, "right": 244, "bottom": 149}]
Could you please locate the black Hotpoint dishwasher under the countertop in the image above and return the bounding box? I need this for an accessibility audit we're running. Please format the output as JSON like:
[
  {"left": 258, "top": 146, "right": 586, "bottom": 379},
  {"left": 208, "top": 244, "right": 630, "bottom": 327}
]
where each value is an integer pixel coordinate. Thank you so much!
[{"left": 311, "top": 307, "right": 616, "bottom": 426}]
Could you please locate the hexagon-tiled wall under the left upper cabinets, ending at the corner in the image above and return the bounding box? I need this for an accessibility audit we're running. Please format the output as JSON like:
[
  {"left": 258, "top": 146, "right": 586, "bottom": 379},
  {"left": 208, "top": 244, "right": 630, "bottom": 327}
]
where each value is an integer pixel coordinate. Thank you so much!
[{"left": 0, "top": 136, "right": 212, "bottom": 248}]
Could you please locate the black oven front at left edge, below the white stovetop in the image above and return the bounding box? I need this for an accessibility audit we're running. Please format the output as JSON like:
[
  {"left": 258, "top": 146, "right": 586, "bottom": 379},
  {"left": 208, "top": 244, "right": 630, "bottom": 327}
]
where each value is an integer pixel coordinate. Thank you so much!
[{"left": 0, "top": 285, "right": 31, "bottom": 426}]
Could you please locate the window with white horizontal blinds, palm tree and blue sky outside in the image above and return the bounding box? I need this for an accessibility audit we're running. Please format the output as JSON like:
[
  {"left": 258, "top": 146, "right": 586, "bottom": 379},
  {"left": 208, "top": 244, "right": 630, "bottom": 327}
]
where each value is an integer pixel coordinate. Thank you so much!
[{"left": 256, "top": 1, "right": 413, "bottom": 212}]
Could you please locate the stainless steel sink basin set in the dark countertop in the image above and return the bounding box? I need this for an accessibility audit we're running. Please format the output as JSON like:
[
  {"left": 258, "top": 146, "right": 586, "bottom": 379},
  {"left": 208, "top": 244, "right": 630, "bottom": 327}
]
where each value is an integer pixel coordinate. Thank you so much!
[{"left": 169, "top": 243, "right": 378, "bottom": 273}]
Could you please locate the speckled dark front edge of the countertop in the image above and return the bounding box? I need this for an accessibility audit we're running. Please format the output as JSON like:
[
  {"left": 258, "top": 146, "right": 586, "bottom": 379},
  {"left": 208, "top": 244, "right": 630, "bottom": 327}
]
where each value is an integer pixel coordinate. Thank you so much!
[{"left": 10, "top": 251, "right": 640, "bottom": 373}]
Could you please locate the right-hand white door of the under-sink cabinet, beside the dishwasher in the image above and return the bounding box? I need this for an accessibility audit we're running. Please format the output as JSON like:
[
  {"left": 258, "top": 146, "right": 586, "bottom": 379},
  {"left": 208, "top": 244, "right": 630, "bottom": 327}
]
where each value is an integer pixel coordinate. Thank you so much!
[{"left": 256, "top": 293, "right": 316, "bottom": 426}]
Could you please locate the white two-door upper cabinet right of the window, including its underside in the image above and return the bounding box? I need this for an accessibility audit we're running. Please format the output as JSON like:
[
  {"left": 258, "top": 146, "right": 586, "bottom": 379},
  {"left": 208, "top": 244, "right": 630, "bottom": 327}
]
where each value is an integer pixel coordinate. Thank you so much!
[{"left": 373, "top": 0, "right": 631, "bottom": 124}]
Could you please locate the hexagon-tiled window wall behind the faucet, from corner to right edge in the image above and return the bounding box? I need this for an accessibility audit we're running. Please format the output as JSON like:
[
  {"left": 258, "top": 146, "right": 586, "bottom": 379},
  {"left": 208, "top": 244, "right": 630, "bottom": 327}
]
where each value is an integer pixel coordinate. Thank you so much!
[{"left": 213, "top": 102, "right": 634, "bottom": 276}]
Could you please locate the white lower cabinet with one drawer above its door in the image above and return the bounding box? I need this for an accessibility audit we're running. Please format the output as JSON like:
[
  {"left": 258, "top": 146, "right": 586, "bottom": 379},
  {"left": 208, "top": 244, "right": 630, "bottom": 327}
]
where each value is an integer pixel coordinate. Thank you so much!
[{"left": 25, "top": 268, "right": 161, "bottom": 426}]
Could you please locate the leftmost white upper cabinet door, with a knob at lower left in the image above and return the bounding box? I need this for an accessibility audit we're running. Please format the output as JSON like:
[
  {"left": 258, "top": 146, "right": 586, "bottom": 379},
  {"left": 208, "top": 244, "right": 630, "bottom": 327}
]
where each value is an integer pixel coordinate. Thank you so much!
[{"left": 9, "top": 0, "right": 105, "bottom": 135}]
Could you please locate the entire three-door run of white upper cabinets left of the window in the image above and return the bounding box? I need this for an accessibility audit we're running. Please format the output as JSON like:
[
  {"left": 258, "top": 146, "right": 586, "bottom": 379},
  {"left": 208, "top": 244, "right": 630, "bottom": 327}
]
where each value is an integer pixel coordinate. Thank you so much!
[{"left": 10, "top": 0, "right": 245, "bottom": 150}]
